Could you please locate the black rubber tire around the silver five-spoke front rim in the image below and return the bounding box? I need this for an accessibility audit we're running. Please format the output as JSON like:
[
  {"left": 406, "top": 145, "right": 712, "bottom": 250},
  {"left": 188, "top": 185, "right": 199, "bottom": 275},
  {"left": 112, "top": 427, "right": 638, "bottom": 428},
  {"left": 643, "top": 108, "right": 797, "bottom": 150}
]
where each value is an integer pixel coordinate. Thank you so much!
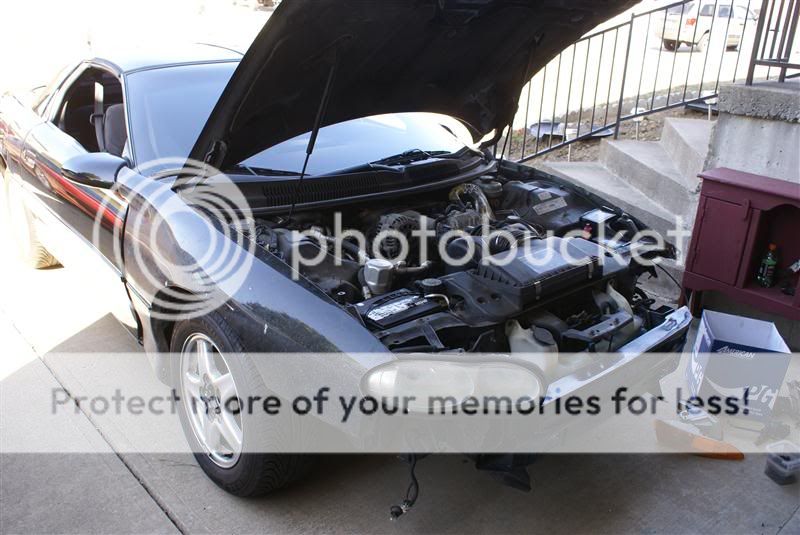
[{"left": 170, "top": 313, "right": 313, "bottom": 497}]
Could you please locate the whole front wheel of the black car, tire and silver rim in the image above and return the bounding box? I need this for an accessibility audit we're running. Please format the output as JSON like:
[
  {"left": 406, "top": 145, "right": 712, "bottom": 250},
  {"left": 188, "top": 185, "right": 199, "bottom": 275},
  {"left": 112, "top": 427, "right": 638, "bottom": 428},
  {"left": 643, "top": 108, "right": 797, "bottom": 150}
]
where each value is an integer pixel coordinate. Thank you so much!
[{"left": 170, "top": 313, "right": 310, "bottom": 497}]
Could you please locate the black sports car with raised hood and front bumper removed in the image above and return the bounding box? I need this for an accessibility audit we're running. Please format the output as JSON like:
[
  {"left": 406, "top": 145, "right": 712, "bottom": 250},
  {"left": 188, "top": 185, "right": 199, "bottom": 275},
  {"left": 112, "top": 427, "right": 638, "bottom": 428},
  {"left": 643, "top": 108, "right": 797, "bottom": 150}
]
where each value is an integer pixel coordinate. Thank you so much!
[{"left": 0, "top": 0, "right": 690, "bottom": 502}]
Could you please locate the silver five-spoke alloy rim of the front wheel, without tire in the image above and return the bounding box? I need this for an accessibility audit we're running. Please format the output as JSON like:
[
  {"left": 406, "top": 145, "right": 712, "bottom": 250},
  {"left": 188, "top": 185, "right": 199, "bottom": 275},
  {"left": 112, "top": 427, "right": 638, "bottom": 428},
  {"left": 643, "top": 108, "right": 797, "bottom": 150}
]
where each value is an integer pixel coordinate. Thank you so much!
[{"left": 180, "top": 333, "right": 243, "bottom": 468}]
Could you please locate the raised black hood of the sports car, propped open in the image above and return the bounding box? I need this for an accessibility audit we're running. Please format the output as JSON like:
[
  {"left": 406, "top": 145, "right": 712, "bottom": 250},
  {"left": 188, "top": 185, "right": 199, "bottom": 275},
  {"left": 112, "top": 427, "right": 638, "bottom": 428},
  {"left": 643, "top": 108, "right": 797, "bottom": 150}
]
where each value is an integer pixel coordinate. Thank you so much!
[{"left": 190, "top": 0, "right": 636, "bottom": 170}]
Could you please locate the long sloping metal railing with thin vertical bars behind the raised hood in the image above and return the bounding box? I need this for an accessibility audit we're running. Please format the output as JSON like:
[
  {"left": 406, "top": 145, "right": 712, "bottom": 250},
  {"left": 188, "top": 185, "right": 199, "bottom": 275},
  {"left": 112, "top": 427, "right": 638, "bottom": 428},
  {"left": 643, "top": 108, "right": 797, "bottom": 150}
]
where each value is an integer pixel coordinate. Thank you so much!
[{"left": 495, "top": 0, "right": 800, "bottom": 162}]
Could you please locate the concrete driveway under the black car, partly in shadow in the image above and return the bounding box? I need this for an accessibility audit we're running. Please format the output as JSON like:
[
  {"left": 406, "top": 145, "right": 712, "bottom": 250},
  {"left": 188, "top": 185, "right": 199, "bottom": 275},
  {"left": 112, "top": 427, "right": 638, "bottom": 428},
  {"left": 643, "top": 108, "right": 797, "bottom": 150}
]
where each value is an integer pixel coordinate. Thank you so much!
[{"left": 0, "top": 206, "right": 800, "bottom": 533}]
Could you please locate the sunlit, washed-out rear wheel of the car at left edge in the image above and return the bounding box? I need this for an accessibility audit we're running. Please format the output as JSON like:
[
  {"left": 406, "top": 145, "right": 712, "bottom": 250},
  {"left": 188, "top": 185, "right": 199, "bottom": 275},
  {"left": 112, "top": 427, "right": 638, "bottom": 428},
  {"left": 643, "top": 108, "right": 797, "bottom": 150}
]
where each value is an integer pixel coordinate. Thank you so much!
[{"left": 3, "top": 170, "right": 58, "bottom": 269}]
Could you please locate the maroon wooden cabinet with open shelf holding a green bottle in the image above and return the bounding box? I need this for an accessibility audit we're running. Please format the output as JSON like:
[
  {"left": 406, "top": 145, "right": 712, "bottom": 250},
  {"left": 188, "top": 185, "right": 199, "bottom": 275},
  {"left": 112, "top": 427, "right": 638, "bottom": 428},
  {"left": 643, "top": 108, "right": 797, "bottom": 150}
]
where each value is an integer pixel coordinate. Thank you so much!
[{"left": 683, "top": 168, "right": 800, "bottom": 321}]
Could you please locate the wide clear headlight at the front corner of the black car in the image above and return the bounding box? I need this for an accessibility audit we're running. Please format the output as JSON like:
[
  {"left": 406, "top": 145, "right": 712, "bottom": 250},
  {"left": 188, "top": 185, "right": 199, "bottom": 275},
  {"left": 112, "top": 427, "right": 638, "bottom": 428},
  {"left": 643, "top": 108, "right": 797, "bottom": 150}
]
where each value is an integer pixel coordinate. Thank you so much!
[{"left": 362, "top": 360, "right": 545, "bottom": 413}]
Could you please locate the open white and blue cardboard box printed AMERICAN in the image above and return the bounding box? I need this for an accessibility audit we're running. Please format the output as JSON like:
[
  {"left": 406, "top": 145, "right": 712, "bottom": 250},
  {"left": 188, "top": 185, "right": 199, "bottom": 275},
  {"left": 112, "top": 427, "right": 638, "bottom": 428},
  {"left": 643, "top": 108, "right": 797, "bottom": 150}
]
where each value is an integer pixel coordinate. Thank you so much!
[{"left": 686, "top": 310, "right": 791, "bottom": 420}]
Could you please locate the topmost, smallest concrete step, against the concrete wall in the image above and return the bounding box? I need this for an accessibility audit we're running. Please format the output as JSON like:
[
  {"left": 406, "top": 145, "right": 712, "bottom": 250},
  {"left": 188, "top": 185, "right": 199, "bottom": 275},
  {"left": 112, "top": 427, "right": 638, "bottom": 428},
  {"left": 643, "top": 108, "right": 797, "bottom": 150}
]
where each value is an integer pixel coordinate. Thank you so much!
[{"left": 661, "top": 117, "right": 716, "bottom": 182}]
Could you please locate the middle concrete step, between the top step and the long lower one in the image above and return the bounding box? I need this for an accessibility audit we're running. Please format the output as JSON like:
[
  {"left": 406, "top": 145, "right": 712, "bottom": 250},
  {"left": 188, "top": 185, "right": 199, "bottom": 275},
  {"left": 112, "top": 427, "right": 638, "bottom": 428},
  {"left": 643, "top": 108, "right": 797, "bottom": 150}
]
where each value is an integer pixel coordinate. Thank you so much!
[{"left": 600, "top": 140, "right": 697, "bottom": 219}]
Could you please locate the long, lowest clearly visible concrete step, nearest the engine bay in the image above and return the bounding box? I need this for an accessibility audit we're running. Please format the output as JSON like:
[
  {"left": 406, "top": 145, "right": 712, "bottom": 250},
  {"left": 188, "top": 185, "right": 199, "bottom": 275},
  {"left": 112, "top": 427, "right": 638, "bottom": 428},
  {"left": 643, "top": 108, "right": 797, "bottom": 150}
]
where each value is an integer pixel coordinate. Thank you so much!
[{"left": 535, "top": 162, "right": 675, "bottom": 239}]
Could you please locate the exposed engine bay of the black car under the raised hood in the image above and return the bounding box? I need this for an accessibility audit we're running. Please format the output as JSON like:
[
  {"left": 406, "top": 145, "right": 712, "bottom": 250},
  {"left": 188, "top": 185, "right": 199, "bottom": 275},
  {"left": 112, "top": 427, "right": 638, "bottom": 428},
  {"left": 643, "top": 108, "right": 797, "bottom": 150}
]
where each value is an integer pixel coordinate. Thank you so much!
[{"left": 241, "top": 173, "right": 672, "bottom": 380}]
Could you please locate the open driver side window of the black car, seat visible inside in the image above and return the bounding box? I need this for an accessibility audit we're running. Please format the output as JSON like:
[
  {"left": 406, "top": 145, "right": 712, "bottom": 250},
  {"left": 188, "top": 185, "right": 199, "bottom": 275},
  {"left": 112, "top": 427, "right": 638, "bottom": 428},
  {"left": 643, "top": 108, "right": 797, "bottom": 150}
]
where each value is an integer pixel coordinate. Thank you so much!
[{"left": 53, "top": 67, "right": 128, "bottom": 156}]
